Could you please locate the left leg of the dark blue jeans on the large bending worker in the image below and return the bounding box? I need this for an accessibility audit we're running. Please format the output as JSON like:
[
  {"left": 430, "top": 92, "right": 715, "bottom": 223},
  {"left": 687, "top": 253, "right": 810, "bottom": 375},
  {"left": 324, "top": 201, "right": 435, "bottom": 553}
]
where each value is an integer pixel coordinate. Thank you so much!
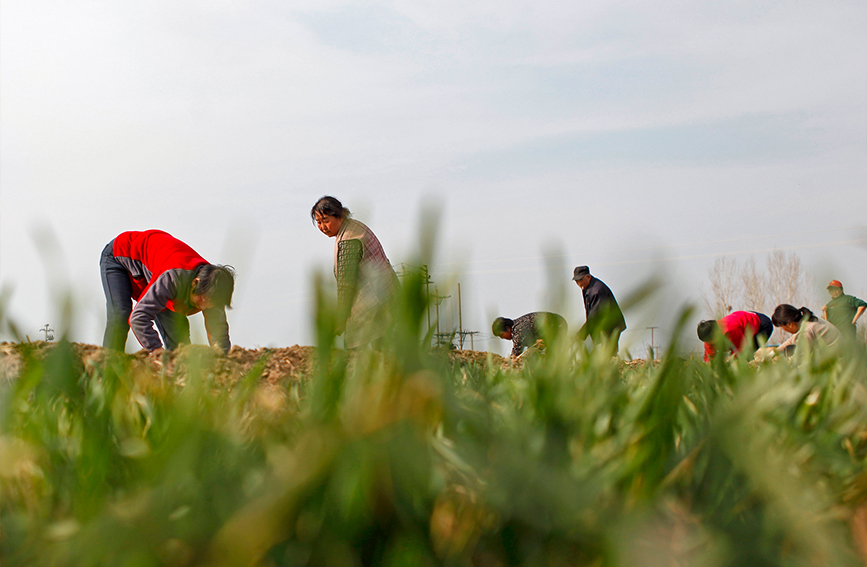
[{"left": 99, "top": 240, "right": 132, "bottom": 352}]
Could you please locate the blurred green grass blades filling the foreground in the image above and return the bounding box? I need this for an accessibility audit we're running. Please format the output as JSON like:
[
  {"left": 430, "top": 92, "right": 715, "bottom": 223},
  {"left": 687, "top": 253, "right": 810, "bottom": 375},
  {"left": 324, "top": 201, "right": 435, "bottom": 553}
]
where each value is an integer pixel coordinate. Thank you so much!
[{"left": 0, "top": 264, "right": 867, "bottom": 567}]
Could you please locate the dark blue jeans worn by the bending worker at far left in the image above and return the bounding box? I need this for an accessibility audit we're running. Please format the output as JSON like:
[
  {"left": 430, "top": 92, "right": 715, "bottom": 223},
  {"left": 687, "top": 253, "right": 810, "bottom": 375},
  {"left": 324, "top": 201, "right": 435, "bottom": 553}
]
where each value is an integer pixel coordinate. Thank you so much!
[{"left": 99, "top": 240, "right": 190, "bottom": 352}]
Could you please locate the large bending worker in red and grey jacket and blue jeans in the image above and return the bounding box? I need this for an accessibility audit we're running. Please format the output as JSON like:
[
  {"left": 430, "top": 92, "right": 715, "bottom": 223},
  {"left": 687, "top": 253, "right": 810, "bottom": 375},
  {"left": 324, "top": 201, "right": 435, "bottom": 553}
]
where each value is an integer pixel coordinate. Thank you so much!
[{"left": 99, "top": 230, "right": 235, "bottom": 352}]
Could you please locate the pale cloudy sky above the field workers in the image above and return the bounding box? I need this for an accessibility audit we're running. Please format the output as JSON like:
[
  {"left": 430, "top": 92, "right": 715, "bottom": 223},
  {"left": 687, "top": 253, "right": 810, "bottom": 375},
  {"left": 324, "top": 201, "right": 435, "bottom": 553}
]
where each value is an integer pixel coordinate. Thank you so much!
[{"left": 0, "top": 0, "right": 867, "bottom": 354}]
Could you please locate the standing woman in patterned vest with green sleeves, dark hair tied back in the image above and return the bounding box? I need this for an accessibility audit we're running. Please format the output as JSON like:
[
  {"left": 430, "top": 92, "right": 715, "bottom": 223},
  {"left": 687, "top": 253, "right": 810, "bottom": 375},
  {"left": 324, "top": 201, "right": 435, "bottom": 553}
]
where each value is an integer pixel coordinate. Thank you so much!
[{"left": 310, "top": 196, "right": 398, "bottom": 348}]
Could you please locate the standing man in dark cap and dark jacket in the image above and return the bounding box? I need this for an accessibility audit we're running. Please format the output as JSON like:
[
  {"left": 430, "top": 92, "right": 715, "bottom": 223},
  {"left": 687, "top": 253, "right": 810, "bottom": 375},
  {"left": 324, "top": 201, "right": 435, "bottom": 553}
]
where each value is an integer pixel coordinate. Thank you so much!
[{"left": 572, "top": 266, "right": 626, "bottom": 353}]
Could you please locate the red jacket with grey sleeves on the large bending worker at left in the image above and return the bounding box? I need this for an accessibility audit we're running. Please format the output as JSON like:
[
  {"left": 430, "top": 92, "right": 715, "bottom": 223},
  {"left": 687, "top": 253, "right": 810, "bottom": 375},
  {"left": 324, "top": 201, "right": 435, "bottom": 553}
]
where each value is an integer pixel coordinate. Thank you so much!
[{"left": 112, "top": 230, "right": 231, "bottom": 350}]
